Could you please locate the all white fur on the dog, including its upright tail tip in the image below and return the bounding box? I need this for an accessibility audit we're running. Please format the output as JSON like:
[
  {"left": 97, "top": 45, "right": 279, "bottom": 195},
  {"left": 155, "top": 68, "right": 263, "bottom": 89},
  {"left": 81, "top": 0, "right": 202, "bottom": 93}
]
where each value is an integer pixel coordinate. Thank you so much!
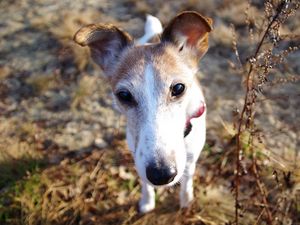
[{"left": 102, "top": 16, "right": 206, "bottom": 213}]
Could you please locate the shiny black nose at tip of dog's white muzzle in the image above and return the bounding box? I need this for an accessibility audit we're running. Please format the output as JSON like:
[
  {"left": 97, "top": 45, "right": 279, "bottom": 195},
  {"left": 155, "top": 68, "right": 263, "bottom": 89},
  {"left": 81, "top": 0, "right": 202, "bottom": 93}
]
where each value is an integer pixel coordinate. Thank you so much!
[{"left": 146, "top": 163, "right": 177, "bottom": 185}]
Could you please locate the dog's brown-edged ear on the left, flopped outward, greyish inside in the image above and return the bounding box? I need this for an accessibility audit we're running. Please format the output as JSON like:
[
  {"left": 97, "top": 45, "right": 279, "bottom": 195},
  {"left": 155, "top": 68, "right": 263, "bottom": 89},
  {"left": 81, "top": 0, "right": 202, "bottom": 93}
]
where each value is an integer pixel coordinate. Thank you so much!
[{"left": 74, "top": 24, "right": 133, "bottom": 76}]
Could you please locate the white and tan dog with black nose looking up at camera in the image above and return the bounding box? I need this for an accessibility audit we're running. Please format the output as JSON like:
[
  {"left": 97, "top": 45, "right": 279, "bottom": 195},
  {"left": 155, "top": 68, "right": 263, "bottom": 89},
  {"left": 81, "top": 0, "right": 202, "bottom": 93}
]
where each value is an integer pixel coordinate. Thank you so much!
[{"left": 74, "top": 11, "right": 212, "bottom": 213}]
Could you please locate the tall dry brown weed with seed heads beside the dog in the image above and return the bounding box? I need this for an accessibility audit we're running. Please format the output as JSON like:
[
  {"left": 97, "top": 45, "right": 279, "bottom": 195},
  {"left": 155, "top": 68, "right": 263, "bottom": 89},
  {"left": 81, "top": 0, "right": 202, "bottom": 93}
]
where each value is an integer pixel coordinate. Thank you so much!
[{"left": 233, "top": 0, "right": 300, "bottom": 224}]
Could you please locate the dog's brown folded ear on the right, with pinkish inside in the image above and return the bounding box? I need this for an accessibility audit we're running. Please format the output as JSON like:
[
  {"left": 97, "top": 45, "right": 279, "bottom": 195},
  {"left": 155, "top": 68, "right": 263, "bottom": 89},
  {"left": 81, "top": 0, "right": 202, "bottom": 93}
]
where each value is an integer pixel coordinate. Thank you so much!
[{"left": 161, "top": 11, "right": 212, "bottom": 60}]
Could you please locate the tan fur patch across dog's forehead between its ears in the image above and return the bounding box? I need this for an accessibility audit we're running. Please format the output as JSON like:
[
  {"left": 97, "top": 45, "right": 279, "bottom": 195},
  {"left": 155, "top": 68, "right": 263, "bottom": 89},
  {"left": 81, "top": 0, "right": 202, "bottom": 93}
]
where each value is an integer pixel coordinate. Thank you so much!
[{"left": 110, "top": 43, "right": 198, "bottom": 89}]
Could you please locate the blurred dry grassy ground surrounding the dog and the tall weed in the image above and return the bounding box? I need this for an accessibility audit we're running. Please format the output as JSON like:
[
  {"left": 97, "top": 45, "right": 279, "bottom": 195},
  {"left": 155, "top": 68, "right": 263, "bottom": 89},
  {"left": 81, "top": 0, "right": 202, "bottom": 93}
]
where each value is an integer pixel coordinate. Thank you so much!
[{"left": 0, "top": 0, "right": 300, "bottom": 224}]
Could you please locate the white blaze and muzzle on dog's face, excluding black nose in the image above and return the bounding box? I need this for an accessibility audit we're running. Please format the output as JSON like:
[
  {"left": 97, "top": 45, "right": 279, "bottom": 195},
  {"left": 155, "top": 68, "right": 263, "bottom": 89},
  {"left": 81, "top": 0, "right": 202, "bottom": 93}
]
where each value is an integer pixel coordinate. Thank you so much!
[{"left": 134, "top": 65, "right": 186, "bottom": 186}]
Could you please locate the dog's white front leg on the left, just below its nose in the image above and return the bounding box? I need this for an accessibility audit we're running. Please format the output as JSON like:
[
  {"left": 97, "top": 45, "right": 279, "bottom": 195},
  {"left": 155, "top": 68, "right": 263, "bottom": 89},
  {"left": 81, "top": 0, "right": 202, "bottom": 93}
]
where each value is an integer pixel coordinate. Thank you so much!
[{"left": 139, "top": 181, "right": 155, "bottom": 213}]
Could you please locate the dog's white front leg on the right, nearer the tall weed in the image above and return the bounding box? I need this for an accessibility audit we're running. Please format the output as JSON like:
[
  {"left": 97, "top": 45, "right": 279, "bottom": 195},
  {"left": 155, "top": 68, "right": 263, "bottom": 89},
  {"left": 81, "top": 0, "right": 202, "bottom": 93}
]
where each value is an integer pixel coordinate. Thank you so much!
[{"left": 180, "top": 162, "right": 196, "bottom": 208}]
